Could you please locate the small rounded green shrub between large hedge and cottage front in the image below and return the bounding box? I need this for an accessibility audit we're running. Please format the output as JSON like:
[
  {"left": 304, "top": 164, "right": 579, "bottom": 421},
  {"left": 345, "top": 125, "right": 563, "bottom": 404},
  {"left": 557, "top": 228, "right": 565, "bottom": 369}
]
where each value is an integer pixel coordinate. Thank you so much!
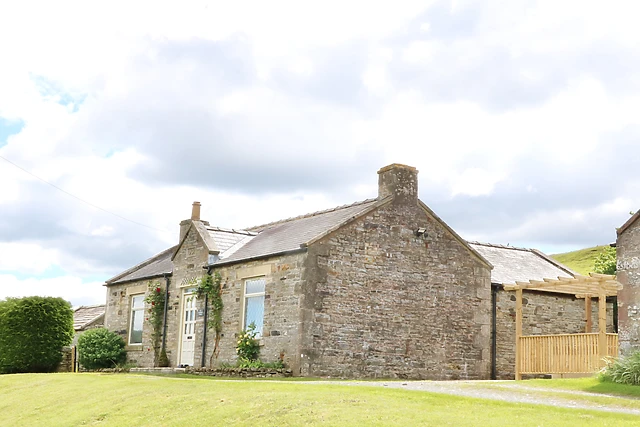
[{"left": 78, "top": 328, "right": 127, "bottom": 369}]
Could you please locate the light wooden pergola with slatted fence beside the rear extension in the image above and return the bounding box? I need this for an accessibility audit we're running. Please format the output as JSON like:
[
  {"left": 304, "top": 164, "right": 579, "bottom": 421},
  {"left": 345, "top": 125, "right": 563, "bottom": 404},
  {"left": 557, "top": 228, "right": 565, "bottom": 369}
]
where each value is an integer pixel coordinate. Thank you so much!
[{"left": 504, "top": 273, "right": 622, "bottom": 380}]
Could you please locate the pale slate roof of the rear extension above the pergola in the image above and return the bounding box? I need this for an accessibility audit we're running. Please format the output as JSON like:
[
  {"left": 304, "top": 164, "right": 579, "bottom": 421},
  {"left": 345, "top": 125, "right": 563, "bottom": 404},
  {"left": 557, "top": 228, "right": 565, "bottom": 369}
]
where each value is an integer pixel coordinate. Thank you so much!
[{"left": 469, "top": 242, "right": 576, "bottom": 284}]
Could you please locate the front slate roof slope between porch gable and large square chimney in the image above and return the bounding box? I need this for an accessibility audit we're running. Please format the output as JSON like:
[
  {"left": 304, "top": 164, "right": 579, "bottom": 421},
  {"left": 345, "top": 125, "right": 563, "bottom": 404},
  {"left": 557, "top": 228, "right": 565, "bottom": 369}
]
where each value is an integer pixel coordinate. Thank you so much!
[{"left": 212, "top": 199, "right": 381, "bottom": 265}]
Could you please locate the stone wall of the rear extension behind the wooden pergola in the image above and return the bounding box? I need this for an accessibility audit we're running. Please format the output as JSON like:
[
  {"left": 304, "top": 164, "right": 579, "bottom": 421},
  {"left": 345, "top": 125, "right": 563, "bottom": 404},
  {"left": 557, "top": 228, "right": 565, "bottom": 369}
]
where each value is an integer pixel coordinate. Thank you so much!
[{"left": 496, "top": 290, "right": 613, "bottom": 379}]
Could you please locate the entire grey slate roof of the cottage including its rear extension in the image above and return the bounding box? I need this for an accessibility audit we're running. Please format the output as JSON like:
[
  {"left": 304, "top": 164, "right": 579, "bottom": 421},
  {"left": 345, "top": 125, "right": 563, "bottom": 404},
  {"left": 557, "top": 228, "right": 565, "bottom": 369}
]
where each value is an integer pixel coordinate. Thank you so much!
[{"left": 107, "top": 199, "right": 576, "bottom": 285}]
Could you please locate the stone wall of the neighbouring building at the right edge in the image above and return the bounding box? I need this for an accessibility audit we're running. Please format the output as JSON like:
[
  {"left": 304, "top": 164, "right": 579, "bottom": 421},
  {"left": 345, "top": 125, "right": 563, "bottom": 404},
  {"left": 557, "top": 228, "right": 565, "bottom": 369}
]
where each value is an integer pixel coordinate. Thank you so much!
[{"left": 616, "top": 221, "right": 640, "bottom": 354}]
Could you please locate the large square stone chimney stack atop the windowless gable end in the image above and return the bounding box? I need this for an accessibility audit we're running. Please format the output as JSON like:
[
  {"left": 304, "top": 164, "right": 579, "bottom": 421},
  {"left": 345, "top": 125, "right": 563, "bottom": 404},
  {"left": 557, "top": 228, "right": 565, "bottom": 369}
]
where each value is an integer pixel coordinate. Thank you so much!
[{"left": 378, "top": 163, "right": 418, "bottom": 203}]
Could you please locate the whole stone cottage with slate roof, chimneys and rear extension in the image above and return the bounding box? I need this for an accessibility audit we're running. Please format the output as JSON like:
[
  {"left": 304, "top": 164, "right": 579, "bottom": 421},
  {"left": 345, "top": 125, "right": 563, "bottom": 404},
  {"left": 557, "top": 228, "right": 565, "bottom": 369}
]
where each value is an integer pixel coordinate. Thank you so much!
[{"left": 105, "top": 164, "right": 608, "bottom": 379}]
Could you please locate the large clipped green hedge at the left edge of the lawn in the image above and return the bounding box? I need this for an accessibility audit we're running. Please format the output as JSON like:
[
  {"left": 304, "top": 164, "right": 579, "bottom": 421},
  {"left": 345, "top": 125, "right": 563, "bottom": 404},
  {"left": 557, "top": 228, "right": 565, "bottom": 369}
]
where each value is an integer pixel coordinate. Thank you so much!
[{"left": 0, "top": 297, "right": 73, "bottom": 373}]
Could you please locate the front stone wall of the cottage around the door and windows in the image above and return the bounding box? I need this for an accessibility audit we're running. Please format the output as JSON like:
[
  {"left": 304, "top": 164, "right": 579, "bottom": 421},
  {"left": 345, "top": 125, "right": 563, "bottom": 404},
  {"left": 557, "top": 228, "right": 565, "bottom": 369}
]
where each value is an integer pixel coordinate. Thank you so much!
[{"left": 105, "top": 226, "right": 305, "bottom": 371}]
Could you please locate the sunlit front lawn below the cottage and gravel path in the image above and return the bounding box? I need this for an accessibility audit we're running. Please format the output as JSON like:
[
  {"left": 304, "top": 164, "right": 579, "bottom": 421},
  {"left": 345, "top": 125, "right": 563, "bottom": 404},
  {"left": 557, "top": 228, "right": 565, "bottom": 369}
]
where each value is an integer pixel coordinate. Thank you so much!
[{"left": 0, "top": 374, "right": 640, "bottom": 426}]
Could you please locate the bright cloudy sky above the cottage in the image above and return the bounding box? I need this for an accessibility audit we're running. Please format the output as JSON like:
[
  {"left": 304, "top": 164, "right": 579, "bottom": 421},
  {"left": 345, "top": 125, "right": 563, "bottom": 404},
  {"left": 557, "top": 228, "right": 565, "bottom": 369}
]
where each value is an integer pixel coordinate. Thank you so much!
[{"left": 0, "top": 0, "right": 640, "bottom": 306}]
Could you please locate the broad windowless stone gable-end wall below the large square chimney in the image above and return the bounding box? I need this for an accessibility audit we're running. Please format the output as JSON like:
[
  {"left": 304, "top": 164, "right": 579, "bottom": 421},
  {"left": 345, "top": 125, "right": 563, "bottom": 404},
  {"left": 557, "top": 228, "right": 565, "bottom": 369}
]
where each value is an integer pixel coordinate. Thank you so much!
[{"left": 301, "top": 199, "right": 491, "bottom": 379}]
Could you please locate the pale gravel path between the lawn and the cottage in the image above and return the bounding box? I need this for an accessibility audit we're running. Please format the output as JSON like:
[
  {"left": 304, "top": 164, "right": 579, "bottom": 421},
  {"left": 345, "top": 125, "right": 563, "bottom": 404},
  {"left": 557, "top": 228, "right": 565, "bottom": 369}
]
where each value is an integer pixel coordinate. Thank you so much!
[{"left": 304, "top": 381, "right": 640, "bottom": 415}]
